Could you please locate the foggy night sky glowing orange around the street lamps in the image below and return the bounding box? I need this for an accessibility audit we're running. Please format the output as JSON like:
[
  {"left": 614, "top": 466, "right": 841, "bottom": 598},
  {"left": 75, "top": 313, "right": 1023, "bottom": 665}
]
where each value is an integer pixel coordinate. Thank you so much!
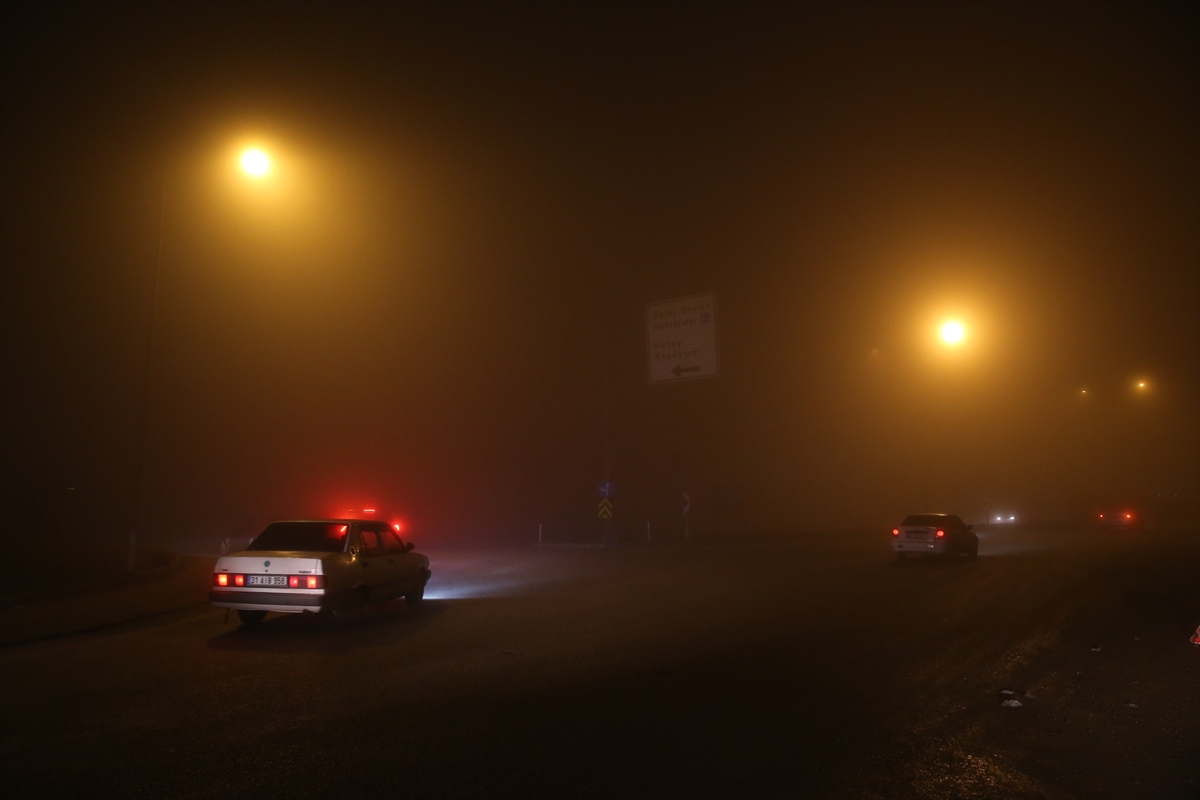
[{"left": 0, "top": 2, "right": 1200, "bottom": 543}]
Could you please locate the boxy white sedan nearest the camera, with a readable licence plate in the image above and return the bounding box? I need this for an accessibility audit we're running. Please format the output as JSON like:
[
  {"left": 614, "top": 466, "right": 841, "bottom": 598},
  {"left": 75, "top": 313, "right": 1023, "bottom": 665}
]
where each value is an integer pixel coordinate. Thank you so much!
[{"left": 209, "top": 519, "right": 432, "bottom": 625}]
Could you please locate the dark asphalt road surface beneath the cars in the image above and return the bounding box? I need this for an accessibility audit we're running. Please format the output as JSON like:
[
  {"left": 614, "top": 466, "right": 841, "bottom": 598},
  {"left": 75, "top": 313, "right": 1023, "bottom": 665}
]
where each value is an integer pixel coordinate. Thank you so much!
[{"left": 0, "top": 530, "right": 1200, "bottom": 799}]
